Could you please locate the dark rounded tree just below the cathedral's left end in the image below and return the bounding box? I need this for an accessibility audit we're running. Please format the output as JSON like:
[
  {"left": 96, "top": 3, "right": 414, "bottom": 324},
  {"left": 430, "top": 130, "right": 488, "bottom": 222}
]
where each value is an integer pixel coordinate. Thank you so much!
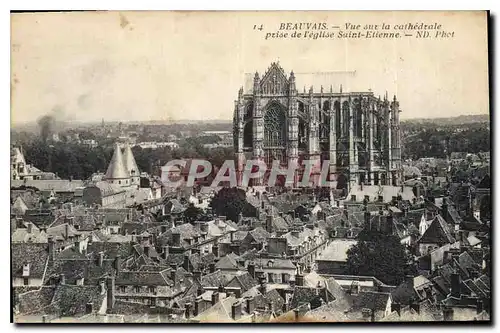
[{"left": 210, "top": 187, "right": 256, "bottom": 221}]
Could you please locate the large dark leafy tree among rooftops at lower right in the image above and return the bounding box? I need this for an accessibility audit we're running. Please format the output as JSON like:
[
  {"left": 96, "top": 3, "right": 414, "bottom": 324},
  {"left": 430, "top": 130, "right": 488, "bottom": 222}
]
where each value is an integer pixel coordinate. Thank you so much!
[{"left": 347, "top": 230, "right": 416, "bottom": 286}]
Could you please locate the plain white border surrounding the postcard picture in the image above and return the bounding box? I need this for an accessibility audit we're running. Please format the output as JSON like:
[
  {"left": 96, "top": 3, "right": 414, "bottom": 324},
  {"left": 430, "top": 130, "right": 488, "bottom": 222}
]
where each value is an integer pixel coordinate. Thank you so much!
[{"left": 0, "top": 0, "right": 500, "bottom": 332}]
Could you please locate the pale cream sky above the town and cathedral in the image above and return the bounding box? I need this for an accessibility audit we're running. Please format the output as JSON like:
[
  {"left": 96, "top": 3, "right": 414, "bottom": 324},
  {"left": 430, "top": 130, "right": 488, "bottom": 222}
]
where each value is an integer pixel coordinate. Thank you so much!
[{"left": 11, "top": 12, "right": 489, "bottom": 123}]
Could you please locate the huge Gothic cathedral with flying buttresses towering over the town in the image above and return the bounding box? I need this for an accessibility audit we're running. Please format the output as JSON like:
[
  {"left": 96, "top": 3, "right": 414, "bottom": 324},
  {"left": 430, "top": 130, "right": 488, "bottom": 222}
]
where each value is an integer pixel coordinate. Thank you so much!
[{"left": 233, "top": 63, "right": 402, "bottom": 190}]
